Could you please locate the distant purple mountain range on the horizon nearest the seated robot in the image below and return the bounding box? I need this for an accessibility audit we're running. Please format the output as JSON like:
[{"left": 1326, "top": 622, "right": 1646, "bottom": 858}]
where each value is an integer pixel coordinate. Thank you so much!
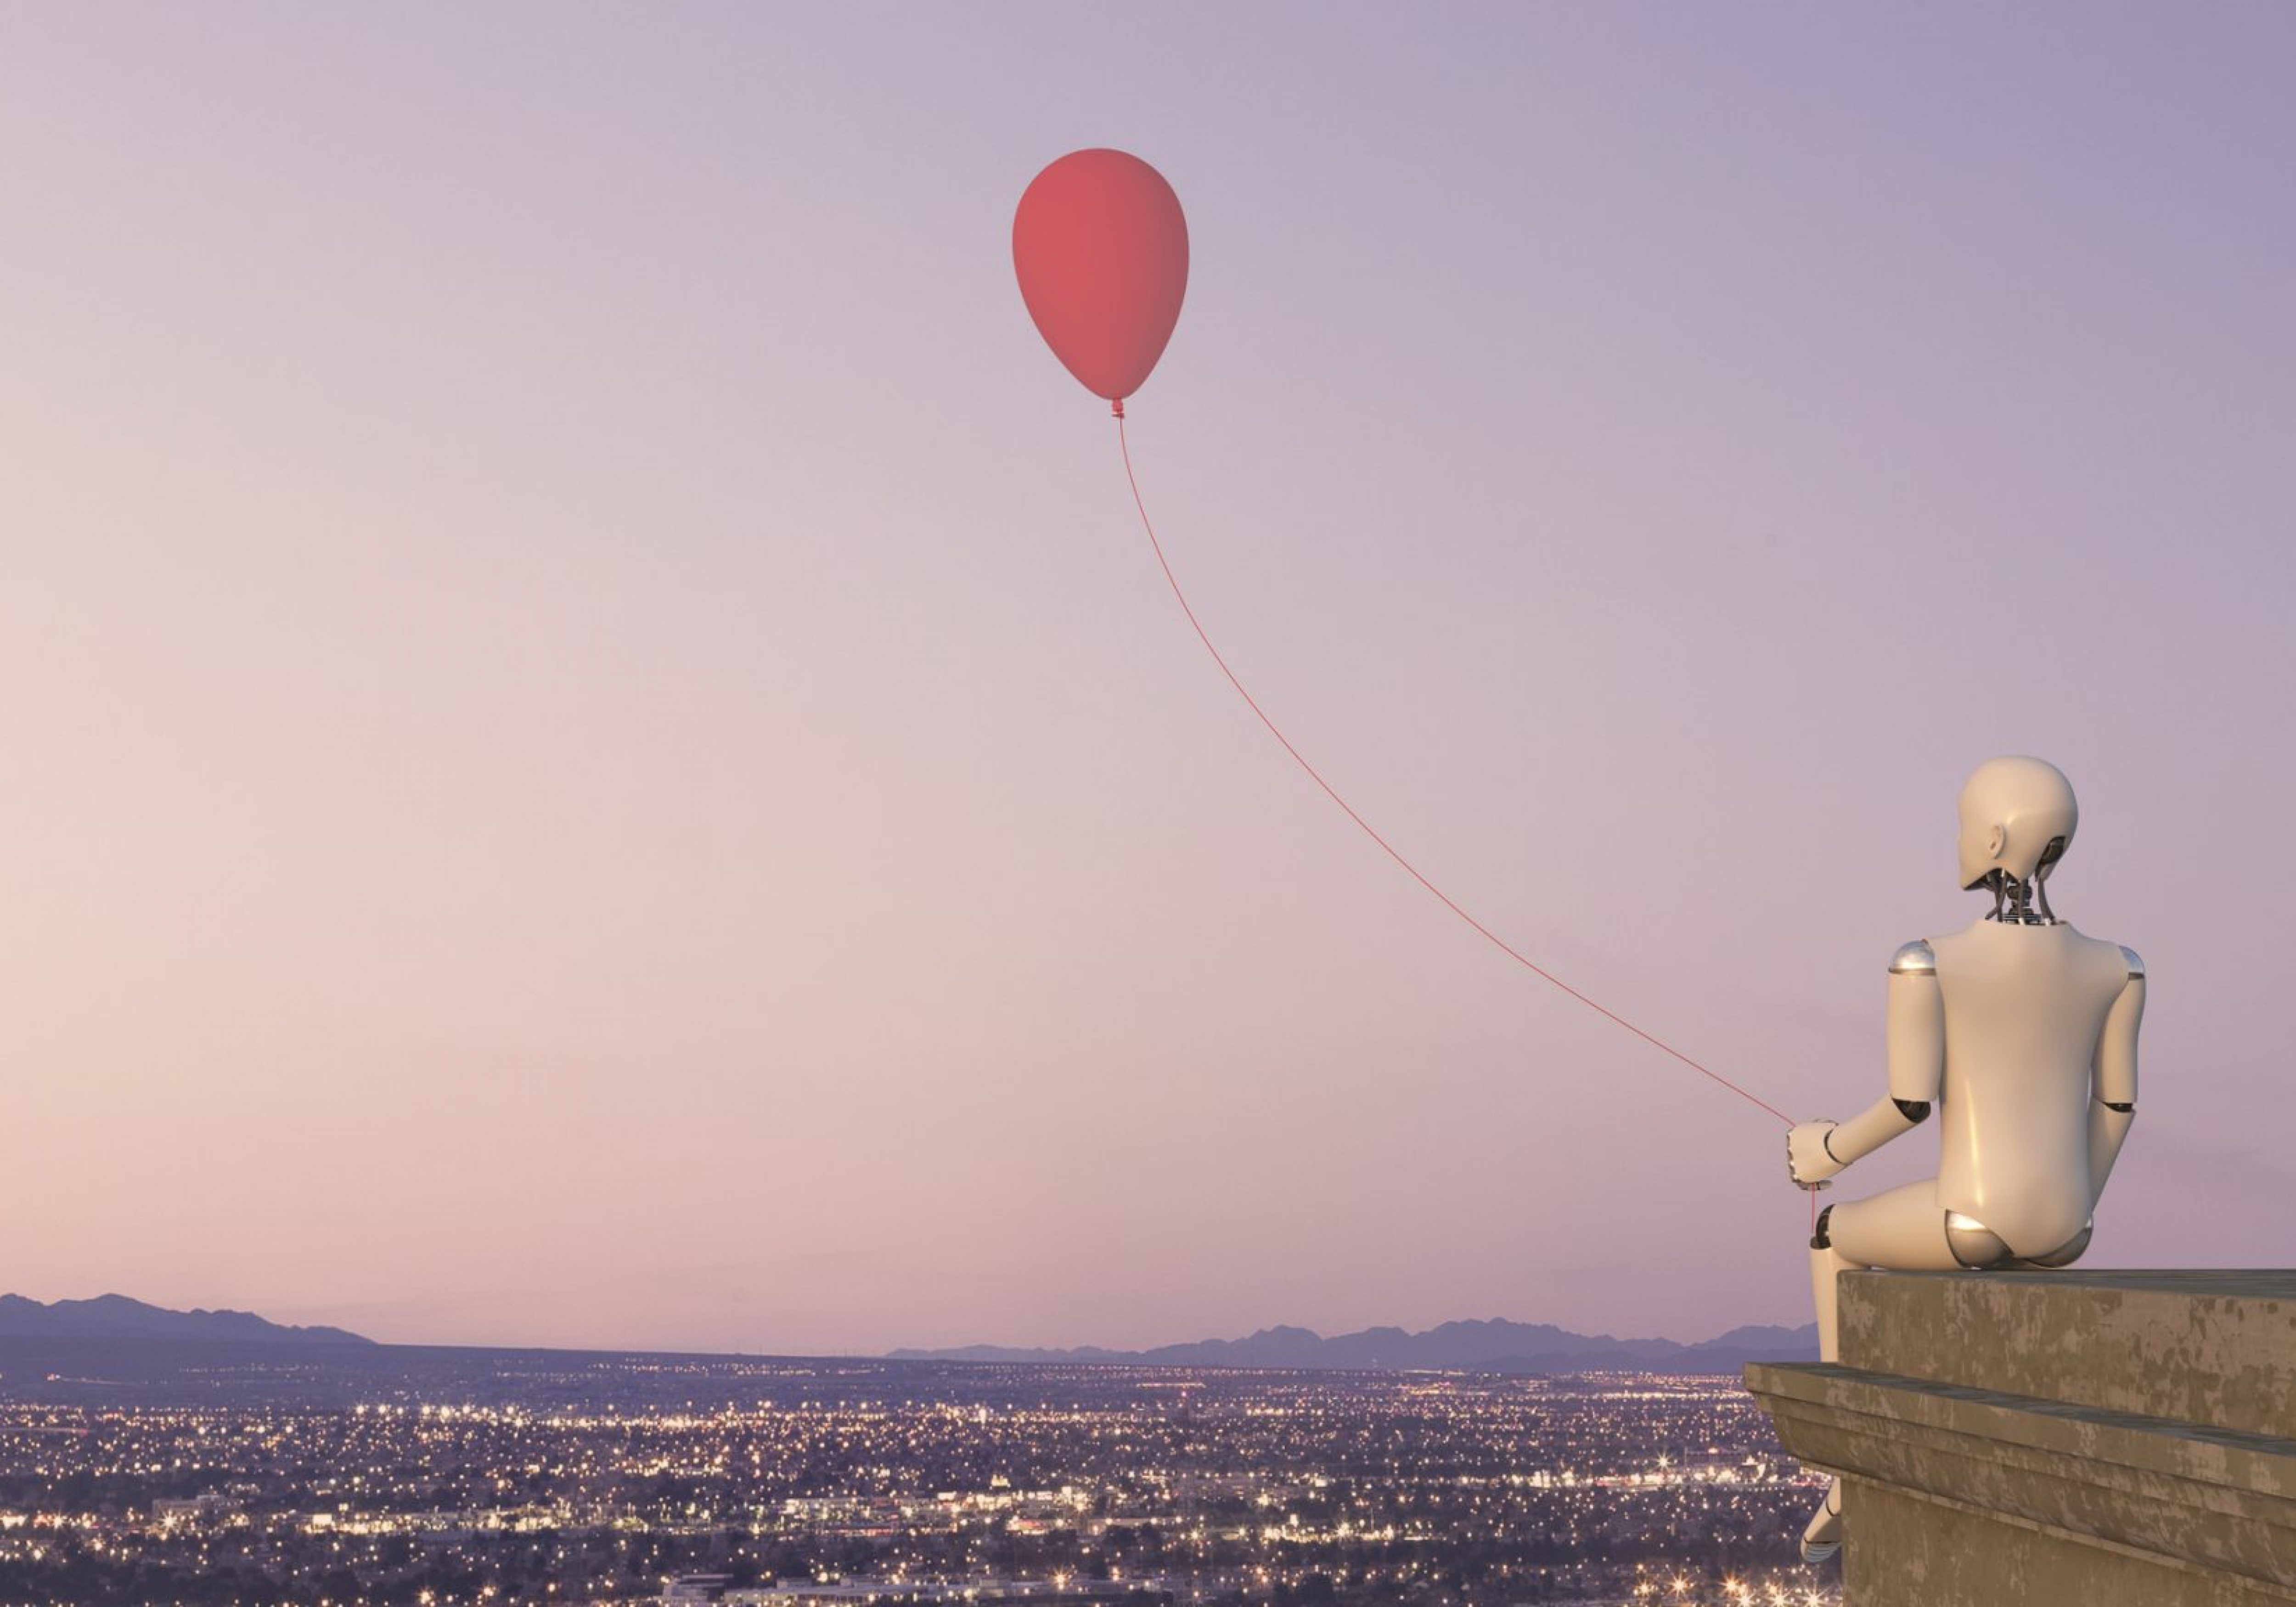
[{"left": 889, "top": 1320, "right": 1818, "bottom": 1375}]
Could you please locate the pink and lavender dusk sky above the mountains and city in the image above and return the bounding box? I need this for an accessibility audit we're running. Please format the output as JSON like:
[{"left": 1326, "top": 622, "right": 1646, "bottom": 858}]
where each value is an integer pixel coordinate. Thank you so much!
[{"left": 0, "top": 5, "right": 2296, "bottom": 1352}]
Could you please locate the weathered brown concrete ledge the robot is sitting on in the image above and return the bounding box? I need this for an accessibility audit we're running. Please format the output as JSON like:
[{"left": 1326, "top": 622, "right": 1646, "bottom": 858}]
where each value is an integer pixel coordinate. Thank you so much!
[{"left": 1747, "top": 1272, "right": 2296, "bottom": 1607}]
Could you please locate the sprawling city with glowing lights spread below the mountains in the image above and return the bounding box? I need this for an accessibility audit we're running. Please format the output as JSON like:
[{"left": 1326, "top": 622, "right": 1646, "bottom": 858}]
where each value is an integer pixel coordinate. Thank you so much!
[{"left": 0, "top": 1357, "right": 1832, "bottom": 1607}]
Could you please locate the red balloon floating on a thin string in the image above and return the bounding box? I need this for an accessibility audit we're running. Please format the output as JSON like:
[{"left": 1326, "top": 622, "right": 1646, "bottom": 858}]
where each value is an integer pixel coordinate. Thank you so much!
[{"left": 1013, "top": 152, "right": 1187, "bottom": 416}]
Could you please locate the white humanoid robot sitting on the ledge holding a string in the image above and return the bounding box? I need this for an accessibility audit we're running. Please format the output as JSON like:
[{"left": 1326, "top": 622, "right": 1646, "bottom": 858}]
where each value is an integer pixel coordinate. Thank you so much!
[{"left": 1786, "top": 758, "right": 2144, "bottom": 1561}]
